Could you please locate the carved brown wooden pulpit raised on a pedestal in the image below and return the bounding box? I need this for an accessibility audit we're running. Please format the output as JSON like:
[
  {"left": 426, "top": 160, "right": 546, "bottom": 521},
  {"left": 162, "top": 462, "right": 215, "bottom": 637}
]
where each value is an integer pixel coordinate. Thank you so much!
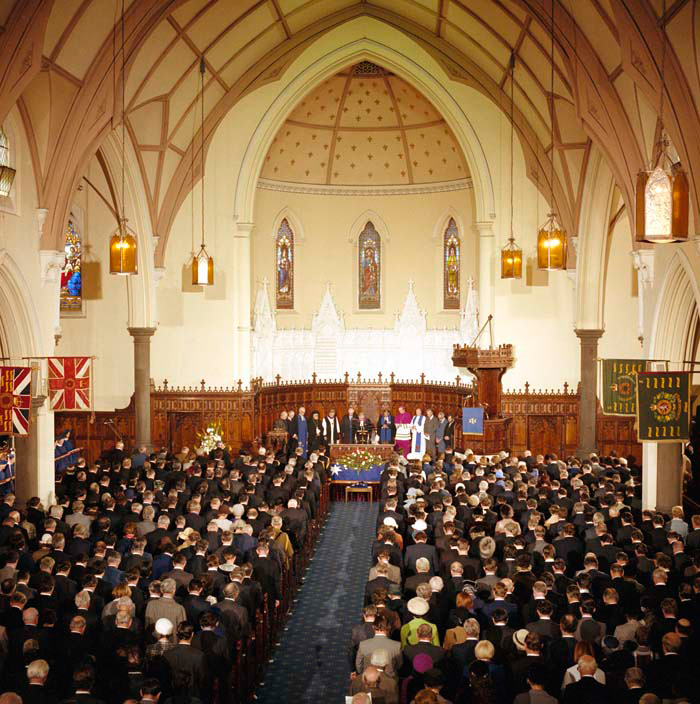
[{"left": 452, "top": 316, "right": 515, "bottom": 454}]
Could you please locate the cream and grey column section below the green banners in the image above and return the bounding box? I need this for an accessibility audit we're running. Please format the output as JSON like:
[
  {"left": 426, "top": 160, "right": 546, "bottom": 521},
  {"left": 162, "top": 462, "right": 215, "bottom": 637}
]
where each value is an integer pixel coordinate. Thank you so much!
[{"left": 642, "top": 442, "right": 683, "bottom": 512}]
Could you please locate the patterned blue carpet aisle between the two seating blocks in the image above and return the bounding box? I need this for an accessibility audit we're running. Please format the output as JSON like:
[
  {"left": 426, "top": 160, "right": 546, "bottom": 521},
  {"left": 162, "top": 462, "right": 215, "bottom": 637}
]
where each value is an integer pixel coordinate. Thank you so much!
[{"left": 257, "top": 503, "right": 378, "bottom": 704}]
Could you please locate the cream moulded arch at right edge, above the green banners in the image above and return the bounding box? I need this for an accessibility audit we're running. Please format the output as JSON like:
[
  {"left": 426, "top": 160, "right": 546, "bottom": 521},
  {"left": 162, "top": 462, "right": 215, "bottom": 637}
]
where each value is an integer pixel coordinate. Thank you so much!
[{"left": 649, "top": 250, "right": 700, "bottom": 366}]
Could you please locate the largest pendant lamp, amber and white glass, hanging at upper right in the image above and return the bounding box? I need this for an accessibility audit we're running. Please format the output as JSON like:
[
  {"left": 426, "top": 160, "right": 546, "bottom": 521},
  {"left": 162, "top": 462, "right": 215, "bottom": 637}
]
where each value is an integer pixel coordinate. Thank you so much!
[{"left": 635, "top": 2, "right": 690, "bottom": 244}]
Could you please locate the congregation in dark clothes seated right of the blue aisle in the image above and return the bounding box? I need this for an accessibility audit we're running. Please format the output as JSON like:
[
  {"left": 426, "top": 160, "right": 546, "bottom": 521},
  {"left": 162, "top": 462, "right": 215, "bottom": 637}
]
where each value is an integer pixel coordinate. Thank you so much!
[{"left": 349, "top": 451, "right": 700, "bottom": 704}]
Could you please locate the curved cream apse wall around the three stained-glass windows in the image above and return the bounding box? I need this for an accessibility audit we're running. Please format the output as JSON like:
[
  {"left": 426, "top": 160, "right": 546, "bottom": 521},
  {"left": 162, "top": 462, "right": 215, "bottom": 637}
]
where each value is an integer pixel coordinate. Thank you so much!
[{"left": 253, "top": 189, "right": 479, "bottom": 329}]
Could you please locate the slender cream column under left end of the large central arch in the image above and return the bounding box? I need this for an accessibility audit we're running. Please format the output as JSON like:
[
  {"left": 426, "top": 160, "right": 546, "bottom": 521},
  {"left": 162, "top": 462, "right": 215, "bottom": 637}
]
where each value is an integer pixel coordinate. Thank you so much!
[{"left": 233, "top": 223, "right": 254, "bottom": 386}]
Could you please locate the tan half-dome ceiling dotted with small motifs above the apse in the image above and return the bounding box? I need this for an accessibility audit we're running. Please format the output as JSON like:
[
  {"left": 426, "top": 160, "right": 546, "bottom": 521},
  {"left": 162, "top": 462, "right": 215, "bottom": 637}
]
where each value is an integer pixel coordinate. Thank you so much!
[{"left": 261, "top": 61, "right": 469, "bottom": 186}]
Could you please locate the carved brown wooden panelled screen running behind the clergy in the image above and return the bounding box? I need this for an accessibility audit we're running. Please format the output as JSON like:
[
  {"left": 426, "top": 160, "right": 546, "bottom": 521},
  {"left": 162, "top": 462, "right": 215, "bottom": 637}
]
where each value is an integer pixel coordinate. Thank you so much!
[{"left": 56, "top": 374, "right": 641, "bottom": 460}]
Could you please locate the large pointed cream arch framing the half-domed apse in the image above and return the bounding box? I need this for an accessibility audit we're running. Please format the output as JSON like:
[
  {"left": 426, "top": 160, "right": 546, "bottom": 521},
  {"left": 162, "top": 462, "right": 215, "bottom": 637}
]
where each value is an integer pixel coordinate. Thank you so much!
[{"left": 234, "top": 38, "right": 496, "bottom": 228}]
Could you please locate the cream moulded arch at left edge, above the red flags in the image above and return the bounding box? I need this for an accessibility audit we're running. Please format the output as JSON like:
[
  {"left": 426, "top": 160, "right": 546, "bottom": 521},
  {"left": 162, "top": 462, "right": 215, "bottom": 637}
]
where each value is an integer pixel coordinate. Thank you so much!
[{"left": 0, "top": 249, "right": 46, "bottom": 362}]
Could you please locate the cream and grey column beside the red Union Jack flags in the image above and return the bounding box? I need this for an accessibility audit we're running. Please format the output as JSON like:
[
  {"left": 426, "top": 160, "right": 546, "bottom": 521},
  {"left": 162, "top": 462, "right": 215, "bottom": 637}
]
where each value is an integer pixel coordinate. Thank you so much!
[{"left": 15, "top": 396, "right": 55, "bottom": 506}]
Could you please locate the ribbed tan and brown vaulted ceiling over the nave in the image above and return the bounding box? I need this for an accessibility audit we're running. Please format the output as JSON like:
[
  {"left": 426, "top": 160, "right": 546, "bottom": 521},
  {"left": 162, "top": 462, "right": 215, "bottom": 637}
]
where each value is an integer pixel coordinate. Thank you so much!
[{"left": 0, "top": 0, "right": 700, "bottom": 264}]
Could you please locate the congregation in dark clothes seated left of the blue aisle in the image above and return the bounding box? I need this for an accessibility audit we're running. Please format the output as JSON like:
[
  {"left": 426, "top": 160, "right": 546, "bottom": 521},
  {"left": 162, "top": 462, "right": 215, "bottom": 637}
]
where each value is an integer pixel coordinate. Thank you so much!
[{"left": 0, "top": 443, "right": 327, "bottom": 704}]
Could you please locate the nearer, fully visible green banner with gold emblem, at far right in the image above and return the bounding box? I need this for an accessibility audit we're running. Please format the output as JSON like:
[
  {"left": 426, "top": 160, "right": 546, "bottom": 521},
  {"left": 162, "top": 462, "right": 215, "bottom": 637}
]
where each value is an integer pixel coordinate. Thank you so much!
[{"left": 637, "top": 372, "right": 690, "bottom": 442}]
